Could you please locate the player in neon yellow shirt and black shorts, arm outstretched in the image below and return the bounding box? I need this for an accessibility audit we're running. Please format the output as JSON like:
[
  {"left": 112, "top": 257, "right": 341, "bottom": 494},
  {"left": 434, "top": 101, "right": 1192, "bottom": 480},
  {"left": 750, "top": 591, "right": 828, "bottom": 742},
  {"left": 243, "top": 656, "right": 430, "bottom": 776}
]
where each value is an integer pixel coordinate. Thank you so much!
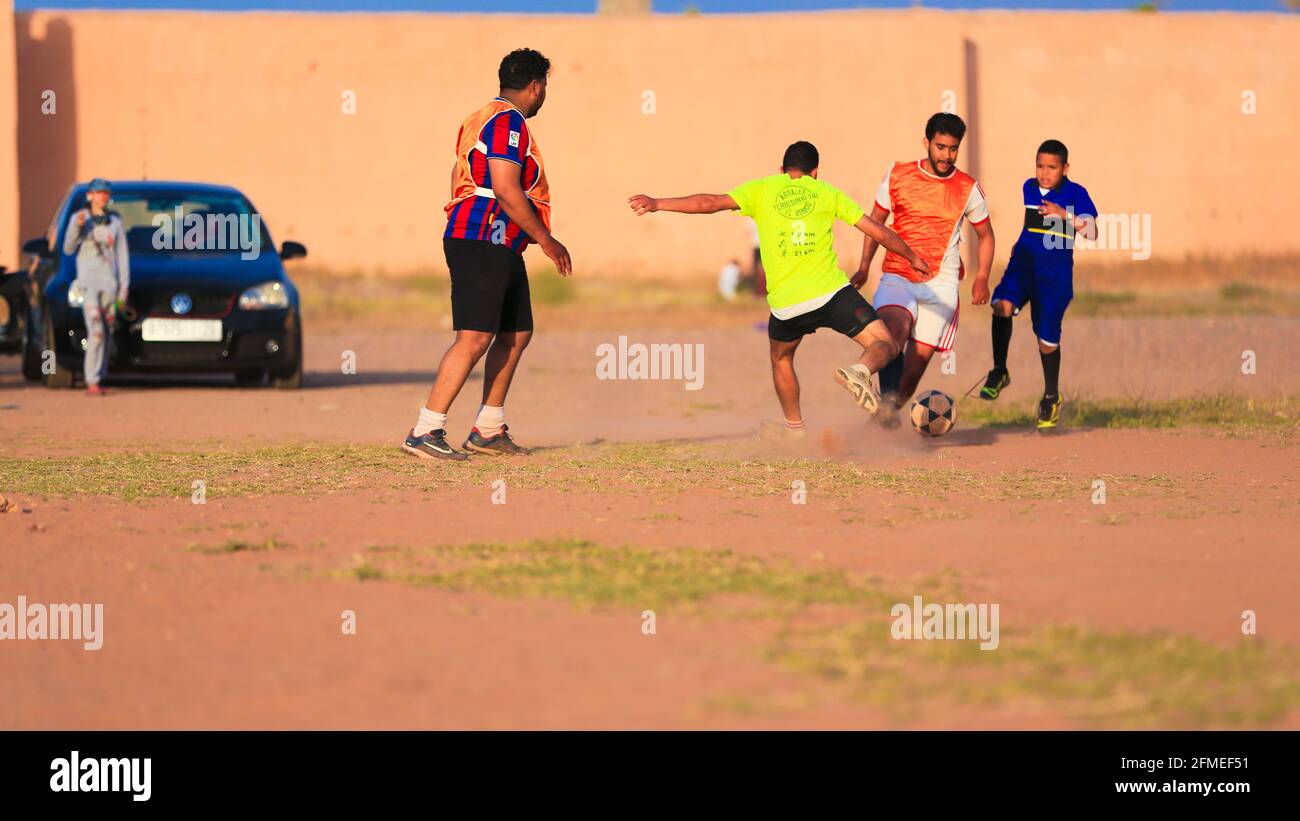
[{"left": 628, "top": 140, "right": 930, "bottom": 435}]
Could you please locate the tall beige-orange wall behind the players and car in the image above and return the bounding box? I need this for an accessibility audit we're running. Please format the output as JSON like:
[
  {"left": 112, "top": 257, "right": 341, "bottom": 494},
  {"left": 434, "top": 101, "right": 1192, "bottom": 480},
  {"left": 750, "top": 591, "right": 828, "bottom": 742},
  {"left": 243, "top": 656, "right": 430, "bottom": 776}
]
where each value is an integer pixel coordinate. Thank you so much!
[{"left": 10, "top": 10, "right": 1300, "bottom": 275}]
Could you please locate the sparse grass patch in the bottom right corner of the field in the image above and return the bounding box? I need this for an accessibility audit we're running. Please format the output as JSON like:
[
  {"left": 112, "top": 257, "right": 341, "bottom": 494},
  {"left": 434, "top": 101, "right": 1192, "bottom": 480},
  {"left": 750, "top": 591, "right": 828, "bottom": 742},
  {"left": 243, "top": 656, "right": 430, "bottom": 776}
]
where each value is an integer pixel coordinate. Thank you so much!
[{"left": 768, "top": 620, "right": 1300, "bottom": 729}]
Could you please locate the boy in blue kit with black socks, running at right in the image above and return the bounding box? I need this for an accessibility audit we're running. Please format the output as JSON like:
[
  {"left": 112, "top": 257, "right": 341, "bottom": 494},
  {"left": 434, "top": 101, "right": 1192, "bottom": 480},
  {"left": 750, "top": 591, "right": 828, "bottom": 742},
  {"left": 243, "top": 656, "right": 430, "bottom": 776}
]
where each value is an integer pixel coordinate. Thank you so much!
[{"left": 979, "top": 140, "right": 1097, "bottom": 431}]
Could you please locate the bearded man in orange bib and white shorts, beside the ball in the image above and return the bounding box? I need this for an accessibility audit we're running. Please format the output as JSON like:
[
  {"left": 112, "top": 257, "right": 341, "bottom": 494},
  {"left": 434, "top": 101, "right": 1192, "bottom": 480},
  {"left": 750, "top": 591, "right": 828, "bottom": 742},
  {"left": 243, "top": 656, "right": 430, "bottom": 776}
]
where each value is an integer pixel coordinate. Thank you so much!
[{"left": 852, "top": 113, "right": 993, "bottom": 426}]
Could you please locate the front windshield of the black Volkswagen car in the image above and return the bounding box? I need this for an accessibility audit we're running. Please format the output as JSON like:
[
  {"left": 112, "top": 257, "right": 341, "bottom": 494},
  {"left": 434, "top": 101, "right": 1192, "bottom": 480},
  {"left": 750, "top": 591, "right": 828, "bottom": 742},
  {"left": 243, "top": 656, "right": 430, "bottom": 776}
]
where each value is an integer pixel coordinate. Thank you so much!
[{"left": 71, "top": 191, "right": 272, "bottom": 253}]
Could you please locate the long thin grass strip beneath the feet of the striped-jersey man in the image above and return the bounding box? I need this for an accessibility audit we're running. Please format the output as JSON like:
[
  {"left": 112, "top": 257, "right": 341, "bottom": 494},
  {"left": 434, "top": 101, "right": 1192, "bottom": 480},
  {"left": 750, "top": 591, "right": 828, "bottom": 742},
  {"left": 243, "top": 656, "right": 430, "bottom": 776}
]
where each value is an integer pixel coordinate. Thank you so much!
[{"left": 0, "top": 439, "right": 1177, "bottom": 501}]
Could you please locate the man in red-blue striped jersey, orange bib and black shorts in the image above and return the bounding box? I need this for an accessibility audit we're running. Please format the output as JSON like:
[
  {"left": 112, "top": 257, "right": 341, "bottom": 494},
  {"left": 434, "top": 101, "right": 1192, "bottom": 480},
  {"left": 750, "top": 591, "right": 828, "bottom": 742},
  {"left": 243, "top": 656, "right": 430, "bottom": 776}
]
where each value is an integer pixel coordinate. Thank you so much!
[{"left": 402, "top": 48, "right": 572, "bottom": 461}]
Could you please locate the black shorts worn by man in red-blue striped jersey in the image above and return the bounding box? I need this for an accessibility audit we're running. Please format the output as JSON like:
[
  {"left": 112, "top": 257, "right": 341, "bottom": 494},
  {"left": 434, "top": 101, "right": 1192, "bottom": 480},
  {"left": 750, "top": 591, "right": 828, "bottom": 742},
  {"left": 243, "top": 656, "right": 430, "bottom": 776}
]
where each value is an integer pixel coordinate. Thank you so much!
[{"left": 442, "top": 236, "right": 533, "bottom": 334}]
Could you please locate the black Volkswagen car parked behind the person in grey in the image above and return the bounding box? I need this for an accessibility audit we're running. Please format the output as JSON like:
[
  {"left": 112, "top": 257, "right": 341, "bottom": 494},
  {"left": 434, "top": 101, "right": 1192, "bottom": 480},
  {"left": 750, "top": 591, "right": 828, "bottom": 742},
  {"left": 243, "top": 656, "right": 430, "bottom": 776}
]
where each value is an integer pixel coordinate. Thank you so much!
[{"left": 18, "top": 182, "right": 307, "bottom": 388}]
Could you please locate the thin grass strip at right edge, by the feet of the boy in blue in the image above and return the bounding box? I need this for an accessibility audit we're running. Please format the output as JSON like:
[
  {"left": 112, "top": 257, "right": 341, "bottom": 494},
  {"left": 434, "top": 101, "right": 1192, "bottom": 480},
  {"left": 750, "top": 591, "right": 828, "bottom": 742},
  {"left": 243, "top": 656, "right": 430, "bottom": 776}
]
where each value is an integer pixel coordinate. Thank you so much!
[{"left": 962, "top": 396, "right": 1300, "bottom": 434}]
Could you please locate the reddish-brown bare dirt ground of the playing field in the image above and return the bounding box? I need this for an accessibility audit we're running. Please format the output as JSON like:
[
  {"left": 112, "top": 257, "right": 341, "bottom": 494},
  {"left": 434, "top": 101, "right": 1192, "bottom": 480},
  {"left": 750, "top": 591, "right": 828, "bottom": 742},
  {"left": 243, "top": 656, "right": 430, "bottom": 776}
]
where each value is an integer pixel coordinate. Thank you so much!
[{"left": 0, "top": 310, "right": 1300, "bottom": 727}]
